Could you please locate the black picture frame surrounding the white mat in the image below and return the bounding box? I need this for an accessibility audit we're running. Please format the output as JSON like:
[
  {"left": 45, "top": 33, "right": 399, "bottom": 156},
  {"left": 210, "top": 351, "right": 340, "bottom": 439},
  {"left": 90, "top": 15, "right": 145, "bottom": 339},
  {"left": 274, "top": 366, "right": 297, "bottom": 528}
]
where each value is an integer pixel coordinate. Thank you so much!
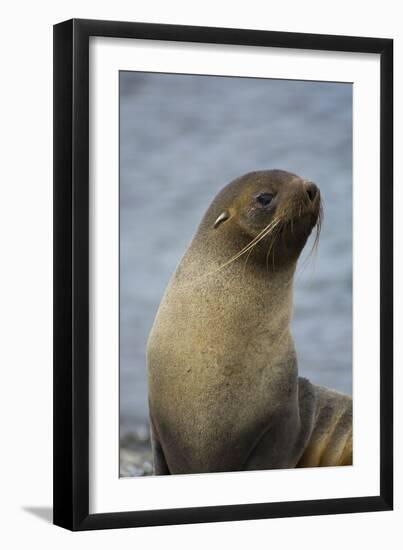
[{"left": 54, "top": 19, "right": 393, "bottom": 530}]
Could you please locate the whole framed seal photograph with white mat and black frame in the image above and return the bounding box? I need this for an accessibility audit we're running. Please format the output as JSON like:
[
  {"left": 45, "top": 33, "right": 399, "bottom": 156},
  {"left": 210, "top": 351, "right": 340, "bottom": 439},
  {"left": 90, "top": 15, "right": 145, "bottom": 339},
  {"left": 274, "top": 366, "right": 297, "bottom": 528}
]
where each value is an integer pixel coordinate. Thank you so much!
[{"left": 54, "top": 20, "right": 393, "bottom": 530}]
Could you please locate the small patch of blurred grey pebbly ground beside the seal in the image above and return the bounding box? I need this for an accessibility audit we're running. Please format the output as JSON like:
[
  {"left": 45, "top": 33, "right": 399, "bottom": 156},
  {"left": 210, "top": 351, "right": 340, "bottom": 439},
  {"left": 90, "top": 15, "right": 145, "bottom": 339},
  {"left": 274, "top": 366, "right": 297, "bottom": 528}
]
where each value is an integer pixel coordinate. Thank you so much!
[{"left": 120, "top": 426, "right": 153, "bottom": 477}]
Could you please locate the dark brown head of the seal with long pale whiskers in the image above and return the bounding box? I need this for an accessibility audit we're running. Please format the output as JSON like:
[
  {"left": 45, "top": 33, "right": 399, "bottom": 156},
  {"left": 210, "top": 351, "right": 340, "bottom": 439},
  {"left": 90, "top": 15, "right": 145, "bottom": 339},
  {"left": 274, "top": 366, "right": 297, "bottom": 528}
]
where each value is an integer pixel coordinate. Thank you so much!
[{"left": 204, "top": 170, "right": 322, "bottom": 267}]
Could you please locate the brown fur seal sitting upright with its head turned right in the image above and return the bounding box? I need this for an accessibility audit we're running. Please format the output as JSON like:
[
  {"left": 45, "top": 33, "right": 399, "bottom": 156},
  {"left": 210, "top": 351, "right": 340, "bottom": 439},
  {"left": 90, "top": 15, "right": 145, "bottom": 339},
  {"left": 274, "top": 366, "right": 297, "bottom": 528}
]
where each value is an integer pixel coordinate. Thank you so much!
[{"left": 147, "top": 170, "right": 352, "bottom": 474}]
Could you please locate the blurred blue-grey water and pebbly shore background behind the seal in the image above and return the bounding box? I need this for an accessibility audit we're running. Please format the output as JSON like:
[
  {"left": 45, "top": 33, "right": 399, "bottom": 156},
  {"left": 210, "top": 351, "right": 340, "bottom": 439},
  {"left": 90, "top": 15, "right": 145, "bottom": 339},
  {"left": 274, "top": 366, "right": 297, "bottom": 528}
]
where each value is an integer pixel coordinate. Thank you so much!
[{"left": 120, "top": 72, "right": 352, "bottom": 476}]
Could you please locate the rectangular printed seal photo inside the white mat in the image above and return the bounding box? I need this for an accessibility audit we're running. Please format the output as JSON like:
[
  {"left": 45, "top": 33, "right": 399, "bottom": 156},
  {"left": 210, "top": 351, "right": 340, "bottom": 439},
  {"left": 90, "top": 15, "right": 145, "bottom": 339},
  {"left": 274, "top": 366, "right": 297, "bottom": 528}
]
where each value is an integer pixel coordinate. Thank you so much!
[{"left": 119, "top": 71, "right": 352, "bottom": 477}]
